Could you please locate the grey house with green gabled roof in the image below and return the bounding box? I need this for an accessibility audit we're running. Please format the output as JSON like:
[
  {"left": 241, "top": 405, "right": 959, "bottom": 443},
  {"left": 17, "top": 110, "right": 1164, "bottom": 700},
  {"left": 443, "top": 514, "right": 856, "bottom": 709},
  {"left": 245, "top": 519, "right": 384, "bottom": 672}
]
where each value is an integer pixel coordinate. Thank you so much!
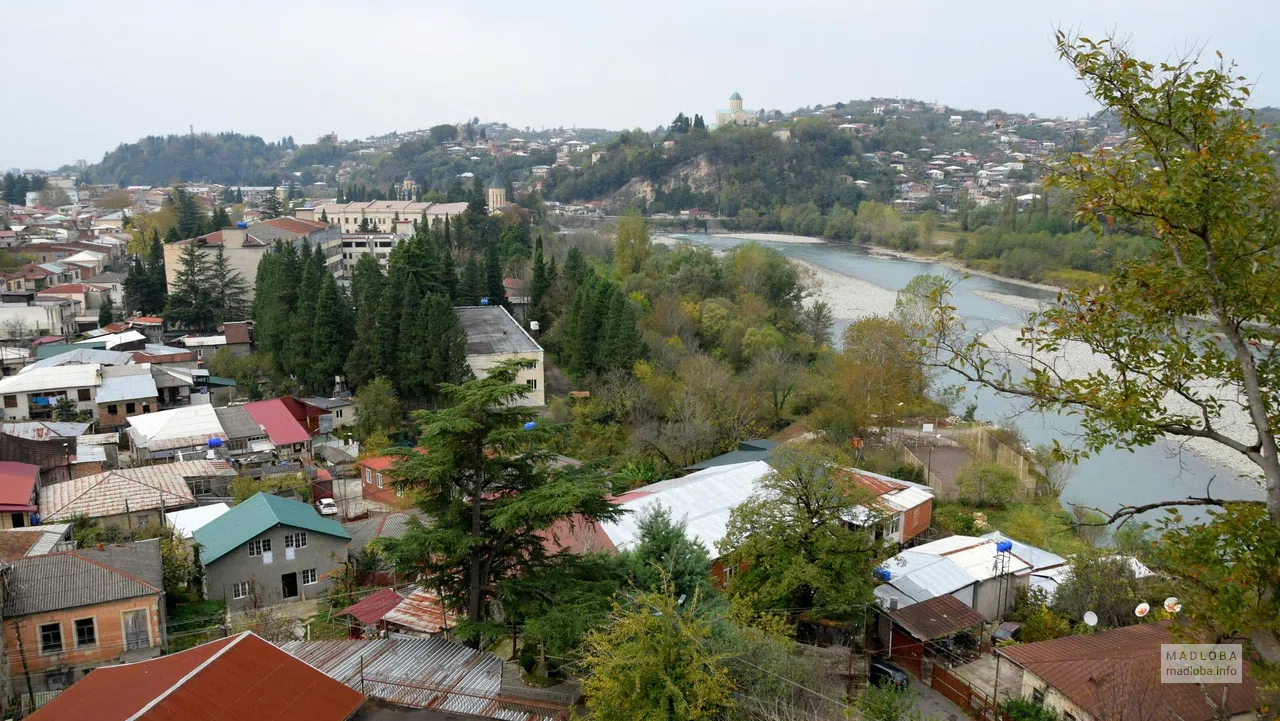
[{"left": 195, "top": 493, "right": 351, "bottom": 611}]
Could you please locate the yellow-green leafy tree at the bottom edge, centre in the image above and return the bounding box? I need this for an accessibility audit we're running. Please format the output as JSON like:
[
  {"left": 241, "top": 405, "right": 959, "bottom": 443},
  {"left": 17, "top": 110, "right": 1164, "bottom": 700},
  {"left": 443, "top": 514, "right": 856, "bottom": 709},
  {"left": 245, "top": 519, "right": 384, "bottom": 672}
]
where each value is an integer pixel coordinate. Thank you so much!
[{"left": 582, "top": 587, "right": 732, "bottom": 721}]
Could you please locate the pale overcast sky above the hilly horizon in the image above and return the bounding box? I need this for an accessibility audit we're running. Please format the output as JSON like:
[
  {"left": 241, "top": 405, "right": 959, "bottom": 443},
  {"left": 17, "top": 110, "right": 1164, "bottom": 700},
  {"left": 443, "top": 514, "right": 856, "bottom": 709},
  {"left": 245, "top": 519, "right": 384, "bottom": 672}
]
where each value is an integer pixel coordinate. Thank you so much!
[{"left": 0, "top": 0, "right": 1280, "bottom": 169}]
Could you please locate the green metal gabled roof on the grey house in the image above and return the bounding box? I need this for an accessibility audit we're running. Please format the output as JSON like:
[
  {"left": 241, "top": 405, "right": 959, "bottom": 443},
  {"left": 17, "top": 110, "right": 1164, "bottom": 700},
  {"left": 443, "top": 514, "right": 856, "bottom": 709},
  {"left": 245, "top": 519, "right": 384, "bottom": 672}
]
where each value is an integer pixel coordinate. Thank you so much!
[{"left": 196, "top": 493, "right": 351, "bottom": 563}]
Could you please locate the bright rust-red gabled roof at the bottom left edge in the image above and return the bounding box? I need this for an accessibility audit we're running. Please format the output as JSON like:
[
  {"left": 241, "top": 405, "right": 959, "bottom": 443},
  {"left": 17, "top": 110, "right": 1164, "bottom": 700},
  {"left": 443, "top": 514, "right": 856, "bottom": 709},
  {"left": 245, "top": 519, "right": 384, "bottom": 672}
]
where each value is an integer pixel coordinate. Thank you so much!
[{"left": 28, "top": 631, "right": 365, "bottom": 721}]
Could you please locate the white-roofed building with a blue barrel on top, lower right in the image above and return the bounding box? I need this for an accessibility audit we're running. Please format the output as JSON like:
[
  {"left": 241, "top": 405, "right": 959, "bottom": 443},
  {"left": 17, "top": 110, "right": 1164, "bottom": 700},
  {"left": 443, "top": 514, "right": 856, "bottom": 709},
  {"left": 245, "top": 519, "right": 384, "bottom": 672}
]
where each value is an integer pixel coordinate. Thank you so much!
[{"left": 874, "top": 535, "right": 1032, "bottom": 620}]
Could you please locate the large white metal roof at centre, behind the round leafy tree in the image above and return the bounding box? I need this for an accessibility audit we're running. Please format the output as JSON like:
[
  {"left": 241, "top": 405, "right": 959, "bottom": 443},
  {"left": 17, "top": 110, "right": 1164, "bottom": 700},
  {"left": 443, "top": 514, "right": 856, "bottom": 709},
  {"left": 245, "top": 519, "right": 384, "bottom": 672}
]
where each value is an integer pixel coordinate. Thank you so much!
[{"left": 600, "top": 461, "right": 773, "bottom": 558}]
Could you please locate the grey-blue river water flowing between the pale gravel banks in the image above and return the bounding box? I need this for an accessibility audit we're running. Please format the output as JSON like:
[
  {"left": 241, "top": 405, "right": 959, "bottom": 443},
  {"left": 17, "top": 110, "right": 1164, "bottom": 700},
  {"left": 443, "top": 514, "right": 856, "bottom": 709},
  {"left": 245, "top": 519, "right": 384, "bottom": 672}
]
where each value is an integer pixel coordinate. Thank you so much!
[{"left": 677, "top": 234, "right": 1263, "bottom": 521}]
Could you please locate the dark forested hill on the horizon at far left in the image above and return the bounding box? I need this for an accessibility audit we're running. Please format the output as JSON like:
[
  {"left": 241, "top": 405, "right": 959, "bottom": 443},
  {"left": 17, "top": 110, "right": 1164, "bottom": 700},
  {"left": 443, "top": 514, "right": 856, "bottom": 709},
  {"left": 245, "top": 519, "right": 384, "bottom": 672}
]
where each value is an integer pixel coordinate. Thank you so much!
[{"left": 78, "top": 133, "right": 293, "bottom": 186}]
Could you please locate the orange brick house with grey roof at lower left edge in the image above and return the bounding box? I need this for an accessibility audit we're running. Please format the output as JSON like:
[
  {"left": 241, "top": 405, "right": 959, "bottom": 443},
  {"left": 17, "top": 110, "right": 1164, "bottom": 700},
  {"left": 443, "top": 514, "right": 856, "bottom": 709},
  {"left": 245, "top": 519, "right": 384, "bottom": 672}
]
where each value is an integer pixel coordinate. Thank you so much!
[{"left": 4, "top": 539, "right": 166, "bottom": 691}]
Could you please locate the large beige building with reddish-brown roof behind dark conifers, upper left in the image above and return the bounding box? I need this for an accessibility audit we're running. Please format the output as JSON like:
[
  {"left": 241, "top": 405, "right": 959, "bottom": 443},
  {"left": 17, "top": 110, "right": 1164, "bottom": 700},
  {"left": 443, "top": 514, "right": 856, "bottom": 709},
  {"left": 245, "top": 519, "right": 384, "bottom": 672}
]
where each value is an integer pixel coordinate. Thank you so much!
[{"left": 164, "top": 218, "right": 342, "bottom": 302}]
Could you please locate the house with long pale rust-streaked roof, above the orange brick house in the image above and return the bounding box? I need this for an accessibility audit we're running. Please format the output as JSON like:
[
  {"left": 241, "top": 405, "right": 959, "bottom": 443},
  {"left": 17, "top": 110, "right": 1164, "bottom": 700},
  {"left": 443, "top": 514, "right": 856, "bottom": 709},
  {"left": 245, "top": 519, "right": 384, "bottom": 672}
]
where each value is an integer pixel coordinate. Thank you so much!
[{"left": 40, "top": 461, "right": 236, "bottom": 530}]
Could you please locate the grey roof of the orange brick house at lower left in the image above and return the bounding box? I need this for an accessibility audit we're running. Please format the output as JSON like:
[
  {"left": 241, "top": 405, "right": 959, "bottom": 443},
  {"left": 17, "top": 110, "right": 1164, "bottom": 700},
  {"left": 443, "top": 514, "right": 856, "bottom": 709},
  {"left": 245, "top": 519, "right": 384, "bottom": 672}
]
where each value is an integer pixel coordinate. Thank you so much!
[{"left": 4, "top": 538, "right": 164, "bottom": 619}]
